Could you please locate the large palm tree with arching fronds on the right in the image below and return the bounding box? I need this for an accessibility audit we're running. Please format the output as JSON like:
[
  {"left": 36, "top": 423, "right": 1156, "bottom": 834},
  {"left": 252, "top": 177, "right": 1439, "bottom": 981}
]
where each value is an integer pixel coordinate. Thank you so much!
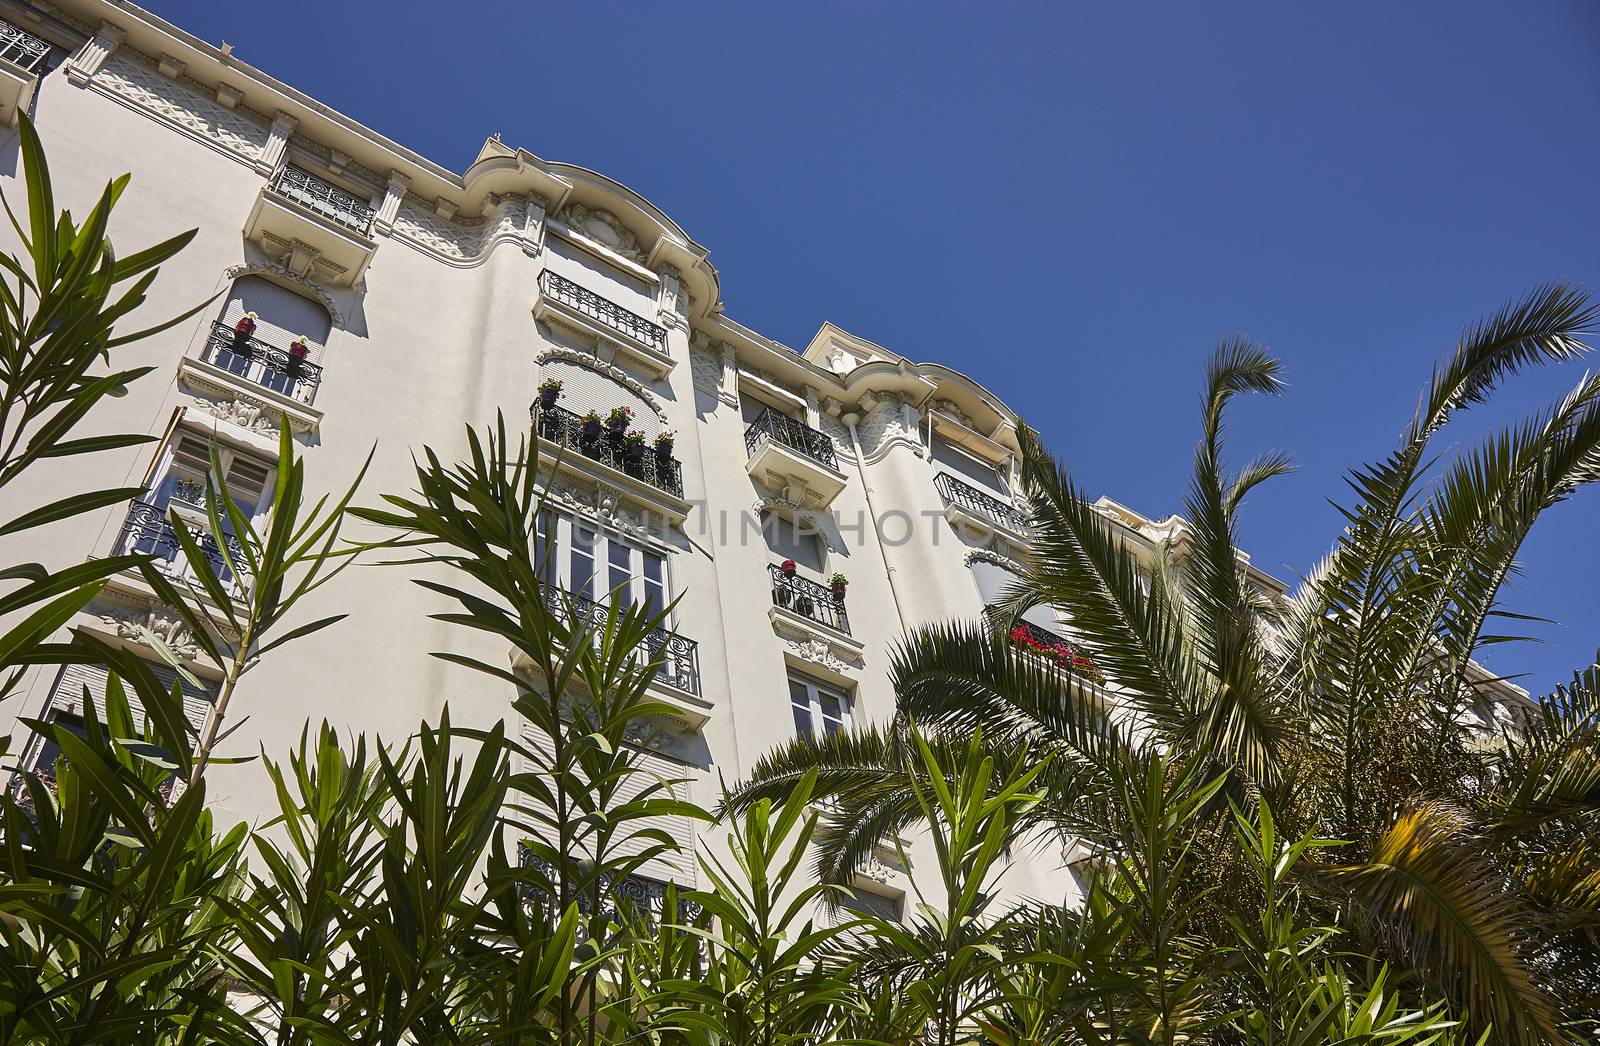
[{"left": 733, "top": 286, "right": 1600, "bottom": 1043}]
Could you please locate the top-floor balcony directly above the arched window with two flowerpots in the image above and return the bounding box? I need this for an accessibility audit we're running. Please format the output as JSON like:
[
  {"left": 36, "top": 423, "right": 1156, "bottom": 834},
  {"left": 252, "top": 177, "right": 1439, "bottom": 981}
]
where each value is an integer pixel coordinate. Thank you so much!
[{"left": 245, "top": 165, "right": 378, "bottom": 286}]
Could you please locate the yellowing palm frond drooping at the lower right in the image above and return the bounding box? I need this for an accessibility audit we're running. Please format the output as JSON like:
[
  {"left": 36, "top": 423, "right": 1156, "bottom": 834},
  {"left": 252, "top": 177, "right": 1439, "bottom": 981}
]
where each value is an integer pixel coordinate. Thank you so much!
[{"left": 1336, "top": 803, "right": 1566, "bottom": 1044}]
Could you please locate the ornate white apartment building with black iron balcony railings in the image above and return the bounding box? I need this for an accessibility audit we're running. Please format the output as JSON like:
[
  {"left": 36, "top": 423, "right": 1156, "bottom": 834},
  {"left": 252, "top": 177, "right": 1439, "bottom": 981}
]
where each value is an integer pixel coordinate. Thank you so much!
[{"left": 0, "top": 0, "right": 1324, "bottom": 910}]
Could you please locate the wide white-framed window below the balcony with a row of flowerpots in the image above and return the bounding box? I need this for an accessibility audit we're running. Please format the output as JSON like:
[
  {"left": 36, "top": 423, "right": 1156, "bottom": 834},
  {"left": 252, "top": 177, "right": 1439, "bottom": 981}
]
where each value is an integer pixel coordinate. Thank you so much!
[{"left": 534, "top": 509, "right": 672, "bottom": 614}]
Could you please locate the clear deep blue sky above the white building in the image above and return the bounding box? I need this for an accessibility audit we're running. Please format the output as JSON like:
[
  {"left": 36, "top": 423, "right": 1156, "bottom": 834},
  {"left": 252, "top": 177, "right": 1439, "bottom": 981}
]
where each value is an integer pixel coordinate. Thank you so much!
[{"left": 150, "top": 0, "right": 1600, "bottom": 700}]
